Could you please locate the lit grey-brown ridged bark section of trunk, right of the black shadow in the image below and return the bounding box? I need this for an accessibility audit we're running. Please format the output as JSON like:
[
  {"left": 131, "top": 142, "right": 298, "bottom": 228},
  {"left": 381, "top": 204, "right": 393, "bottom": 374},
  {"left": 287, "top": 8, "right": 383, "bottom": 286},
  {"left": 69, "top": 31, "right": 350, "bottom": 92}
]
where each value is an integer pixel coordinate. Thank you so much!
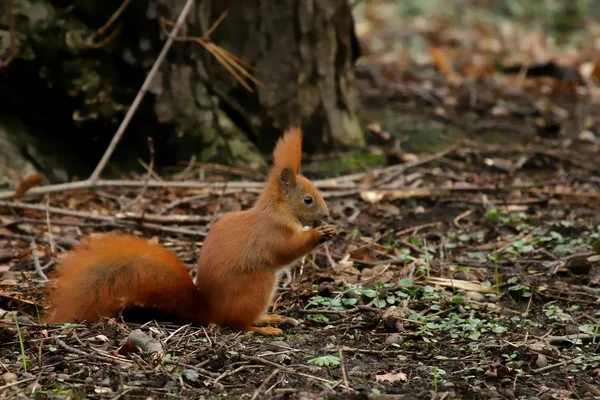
[{"left": 150, "top": 0, "right": 364, "bottom": 163}]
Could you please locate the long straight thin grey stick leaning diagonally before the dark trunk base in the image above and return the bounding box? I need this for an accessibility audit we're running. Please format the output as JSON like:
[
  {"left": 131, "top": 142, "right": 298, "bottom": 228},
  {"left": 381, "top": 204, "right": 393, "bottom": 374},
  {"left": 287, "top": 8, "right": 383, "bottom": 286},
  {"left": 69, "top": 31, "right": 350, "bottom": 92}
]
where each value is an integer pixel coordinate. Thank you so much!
[{"left": 89, "top": 0, "right": 194, "bottom": 185}]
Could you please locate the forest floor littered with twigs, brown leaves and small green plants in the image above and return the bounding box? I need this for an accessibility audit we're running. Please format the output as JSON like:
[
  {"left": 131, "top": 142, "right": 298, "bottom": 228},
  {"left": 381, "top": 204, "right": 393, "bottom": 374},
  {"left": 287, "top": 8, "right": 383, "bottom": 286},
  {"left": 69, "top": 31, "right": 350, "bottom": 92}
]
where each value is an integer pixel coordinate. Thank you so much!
[{"left": 0, "top": 0, "right": 600, "bottom": 399}]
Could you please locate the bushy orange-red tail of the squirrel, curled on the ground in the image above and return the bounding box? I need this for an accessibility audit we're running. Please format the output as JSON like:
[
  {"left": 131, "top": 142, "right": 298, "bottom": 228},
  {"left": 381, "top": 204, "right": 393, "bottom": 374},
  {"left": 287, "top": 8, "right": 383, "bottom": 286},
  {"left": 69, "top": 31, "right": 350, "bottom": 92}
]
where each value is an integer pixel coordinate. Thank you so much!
[{"left": 43, "top": 234, "right": 207, "bottom": 323}]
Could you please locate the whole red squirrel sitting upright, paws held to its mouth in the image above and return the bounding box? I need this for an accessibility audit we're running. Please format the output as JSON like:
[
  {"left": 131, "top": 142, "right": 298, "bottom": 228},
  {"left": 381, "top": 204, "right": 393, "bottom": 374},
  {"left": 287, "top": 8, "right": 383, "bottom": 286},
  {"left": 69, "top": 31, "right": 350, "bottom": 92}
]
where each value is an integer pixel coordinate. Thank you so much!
[{"left": 45, "top": 127, "right": 337, "bottom": 335}]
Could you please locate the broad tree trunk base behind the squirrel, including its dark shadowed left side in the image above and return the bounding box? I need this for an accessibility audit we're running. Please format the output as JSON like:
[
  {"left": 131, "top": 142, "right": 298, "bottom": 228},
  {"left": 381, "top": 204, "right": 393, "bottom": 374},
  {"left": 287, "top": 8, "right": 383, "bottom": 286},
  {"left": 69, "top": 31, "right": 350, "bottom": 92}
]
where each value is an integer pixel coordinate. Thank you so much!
[{"left": 0, "top": 0, "right": 364, "bottom": 180}]
